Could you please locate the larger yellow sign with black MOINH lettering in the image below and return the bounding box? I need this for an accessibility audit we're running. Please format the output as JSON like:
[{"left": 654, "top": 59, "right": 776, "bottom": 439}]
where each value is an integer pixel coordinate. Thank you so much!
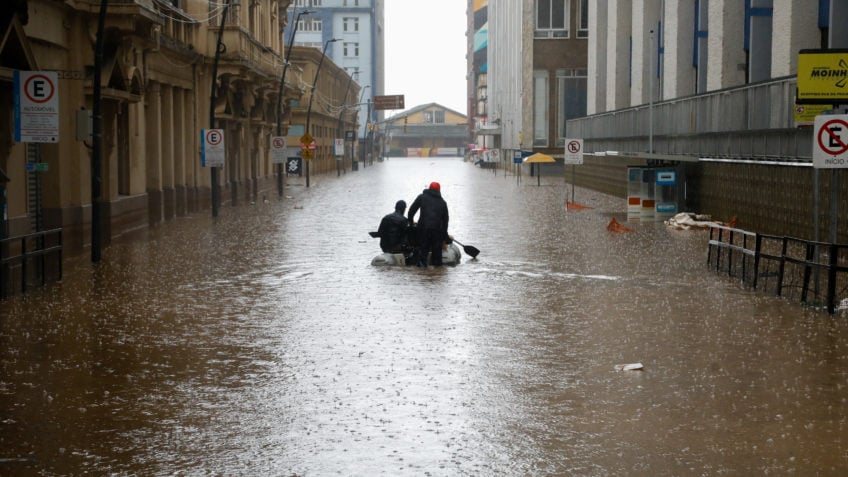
[{"left": 795, "top": 50, "right": 848, "bottom": 104}]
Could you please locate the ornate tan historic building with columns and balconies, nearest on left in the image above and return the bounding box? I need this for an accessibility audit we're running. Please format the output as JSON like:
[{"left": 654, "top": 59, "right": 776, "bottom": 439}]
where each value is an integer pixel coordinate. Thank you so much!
[{"left": 0, "top": 0, "right": 353, "bottom": 251}]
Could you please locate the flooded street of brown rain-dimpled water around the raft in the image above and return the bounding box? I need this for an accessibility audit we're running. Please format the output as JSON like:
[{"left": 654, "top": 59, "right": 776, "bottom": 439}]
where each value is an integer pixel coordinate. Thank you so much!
[{"left": 0, "top": 159, "right": 848, "bottom": 476}]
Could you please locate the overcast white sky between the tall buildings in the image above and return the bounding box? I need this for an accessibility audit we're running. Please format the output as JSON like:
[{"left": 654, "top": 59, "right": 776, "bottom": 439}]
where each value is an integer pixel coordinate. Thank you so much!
[{"left": 384, "top": 0, "right": 468, "bottom": 114}]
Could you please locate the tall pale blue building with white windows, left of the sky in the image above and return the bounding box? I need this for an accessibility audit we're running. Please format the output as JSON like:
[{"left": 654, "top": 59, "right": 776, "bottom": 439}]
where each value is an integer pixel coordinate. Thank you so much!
[{"left": 285, "top": 0, "right": 385, "bottom": 138}]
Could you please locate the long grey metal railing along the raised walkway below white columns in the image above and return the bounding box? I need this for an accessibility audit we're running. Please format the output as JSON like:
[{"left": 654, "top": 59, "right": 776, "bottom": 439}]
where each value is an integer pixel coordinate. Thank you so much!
[{"left": 567, "top": 76, "right": 812, "bottom": 162}]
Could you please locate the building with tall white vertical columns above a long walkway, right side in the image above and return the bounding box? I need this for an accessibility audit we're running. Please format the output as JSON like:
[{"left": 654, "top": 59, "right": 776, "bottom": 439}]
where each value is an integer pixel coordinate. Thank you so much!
[{"left": 568, "top": 0, "right": 848, "bottom": 238}]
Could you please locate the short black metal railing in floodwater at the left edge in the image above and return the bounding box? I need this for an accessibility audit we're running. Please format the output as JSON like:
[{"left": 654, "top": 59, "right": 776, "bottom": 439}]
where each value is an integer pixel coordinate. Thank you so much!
[{"left": 0, "top": 229, "right": 62, "bottom": 298}]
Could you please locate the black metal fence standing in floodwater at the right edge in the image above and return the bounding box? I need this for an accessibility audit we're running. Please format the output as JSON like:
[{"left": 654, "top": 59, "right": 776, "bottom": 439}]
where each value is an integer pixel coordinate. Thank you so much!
[{"left": 707, "top": 225, "right": 848, "bottom": 314}]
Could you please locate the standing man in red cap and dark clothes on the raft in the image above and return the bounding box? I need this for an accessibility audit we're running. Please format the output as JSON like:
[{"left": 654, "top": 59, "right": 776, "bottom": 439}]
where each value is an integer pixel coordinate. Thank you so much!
[{"left": 407, "top": 182, "right": 448, "bottom": 267}]
